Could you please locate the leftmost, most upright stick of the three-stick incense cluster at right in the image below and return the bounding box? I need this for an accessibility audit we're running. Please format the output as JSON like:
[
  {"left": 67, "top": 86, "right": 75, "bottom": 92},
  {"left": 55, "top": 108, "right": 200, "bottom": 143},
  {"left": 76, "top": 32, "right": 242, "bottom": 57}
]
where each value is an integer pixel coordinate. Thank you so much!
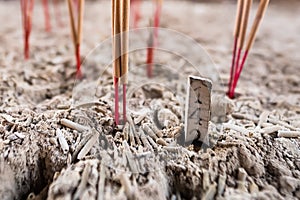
[{"left": 227, "top": 0, "right": 244, "bottom": 95}]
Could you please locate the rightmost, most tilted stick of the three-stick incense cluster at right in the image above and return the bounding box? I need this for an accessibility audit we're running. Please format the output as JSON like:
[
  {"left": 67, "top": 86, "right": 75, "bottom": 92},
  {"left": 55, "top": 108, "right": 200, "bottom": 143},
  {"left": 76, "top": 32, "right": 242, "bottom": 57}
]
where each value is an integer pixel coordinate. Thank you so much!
[{"left": 232, "top": 0, "right": 269, "bottom": 95}]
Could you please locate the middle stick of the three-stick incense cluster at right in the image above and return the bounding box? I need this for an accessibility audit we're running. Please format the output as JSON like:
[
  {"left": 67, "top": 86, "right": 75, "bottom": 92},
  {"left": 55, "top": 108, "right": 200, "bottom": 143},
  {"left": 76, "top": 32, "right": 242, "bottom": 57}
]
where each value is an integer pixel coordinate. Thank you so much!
[{"left": 229, "top": 0, "right": 252, "bottom": 98}]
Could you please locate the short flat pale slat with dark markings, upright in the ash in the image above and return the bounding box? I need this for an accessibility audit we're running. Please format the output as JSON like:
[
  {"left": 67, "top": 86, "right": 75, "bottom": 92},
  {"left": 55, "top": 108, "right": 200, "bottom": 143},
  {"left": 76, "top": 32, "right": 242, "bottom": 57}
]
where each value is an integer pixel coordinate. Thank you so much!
[{"left": 185, "top": 76, "right": 212, "bottom": 144}]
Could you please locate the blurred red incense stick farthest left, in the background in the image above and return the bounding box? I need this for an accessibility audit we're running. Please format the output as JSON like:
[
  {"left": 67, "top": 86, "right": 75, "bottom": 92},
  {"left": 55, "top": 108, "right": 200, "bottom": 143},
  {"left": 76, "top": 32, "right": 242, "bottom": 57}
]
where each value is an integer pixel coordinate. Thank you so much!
[{"left": 20, "top": 0, "right": 34, "bottom": 60}]
